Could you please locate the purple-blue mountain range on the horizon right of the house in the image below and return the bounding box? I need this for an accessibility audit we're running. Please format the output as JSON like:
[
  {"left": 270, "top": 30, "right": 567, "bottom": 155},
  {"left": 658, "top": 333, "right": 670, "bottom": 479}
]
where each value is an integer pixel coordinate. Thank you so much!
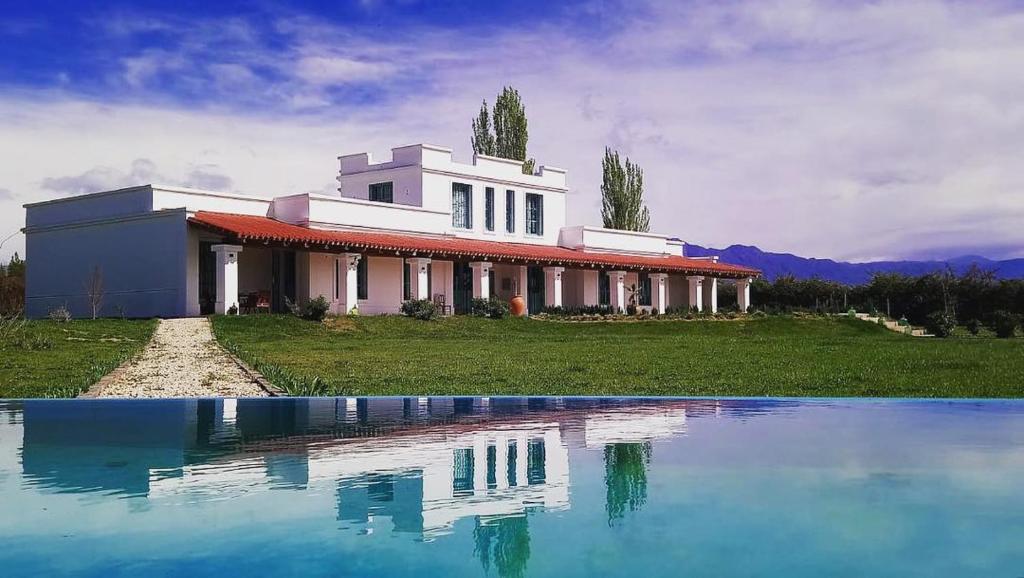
[{"left": 686, "top": 243, "right": 1024, "bottom": 285}]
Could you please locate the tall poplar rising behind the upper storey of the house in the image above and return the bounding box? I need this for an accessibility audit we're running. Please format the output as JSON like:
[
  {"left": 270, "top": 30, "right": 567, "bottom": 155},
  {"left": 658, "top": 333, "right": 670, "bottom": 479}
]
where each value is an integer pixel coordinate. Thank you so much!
[{"left": 470, "top": 86, "right": 537, "bottom": 174}]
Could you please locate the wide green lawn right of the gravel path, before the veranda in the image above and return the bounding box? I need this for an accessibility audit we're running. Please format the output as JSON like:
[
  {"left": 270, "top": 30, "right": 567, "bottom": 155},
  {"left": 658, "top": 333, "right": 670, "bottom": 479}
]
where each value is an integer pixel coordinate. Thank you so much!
[{"left": 213, "top": 316, "right": 1024, "bottom": 398}]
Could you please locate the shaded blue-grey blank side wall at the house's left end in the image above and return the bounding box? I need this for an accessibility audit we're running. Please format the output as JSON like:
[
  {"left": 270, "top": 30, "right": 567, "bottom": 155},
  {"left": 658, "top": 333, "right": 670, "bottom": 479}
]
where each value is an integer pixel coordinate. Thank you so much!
[{"left": 26, "top": 210, "right": 189, "bottom": 318}]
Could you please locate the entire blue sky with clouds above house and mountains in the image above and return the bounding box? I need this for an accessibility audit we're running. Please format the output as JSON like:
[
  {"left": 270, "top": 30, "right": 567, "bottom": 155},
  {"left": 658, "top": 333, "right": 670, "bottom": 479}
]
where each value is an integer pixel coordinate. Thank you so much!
[{"left": 0, "top": 0, "right": 1024, "bottom": 260}]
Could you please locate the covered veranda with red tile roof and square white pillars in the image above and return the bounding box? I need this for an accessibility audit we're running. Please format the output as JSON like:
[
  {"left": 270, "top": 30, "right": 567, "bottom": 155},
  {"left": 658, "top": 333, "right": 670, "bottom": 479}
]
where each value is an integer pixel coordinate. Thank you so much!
[{"left": 188, "top": 211, "right": 758, "bottom": 315}]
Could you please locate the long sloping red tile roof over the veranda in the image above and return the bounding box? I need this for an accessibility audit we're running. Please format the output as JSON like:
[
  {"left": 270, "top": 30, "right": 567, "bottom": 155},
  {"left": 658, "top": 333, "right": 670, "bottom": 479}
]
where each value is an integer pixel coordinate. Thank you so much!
[{"left": 188, "top": 211, "right": 760, "bottom": 278}]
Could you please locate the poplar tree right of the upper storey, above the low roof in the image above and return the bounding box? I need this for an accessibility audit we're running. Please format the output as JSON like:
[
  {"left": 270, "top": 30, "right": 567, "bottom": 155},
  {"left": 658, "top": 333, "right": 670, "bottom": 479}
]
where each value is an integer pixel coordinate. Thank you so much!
[{"left": 601, "top": 147, "right": 650, "bottom": 233}]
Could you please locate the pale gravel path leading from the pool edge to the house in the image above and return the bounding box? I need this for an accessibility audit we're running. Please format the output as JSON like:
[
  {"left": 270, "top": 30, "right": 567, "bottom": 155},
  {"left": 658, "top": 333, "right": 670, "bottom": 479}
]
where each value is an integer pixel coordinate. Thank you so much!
[{"left": 95, "top": 318, "right": 266, "bottom": 398}]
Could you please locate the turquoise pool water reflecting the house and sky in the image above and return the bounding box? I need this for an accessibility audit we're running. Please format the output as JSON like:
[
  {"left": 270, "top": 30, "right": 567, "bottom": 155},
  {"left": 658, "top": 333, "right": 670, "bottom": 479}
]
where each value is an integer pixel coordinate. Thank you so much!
[{"left": 0, "top": 398, "right": 1024, "bottom": 578}]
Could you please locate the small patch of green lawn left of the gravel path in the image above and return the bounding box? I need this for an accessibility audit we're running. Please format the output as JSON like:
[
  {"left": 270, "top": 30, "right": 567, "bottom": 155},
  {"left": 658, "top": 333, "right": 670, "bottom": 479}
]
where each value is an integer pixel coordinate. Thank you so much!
[{"left": 0, "top": 319, "right": 157, "bottom": 398}]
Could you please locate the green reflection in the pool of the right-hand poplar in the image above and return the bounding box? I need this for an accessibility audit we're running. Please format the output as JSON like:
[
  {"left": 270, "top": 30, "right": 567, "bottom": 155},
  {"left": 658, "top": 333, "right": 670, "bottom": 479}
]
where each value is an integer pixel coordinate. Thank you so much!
[{"left": 604, "top": 442, "right": 650, "bottom": 525}]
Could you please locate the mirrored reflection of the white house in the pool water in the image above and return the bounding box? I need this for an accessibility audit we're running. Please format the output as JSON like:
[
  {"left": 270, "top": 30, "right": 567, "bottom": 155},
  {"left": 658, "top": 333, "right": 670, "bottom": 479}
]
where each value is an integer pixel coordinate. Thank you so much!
[{"left": 14, "top": 398, "right": 713, "bottom": 539}]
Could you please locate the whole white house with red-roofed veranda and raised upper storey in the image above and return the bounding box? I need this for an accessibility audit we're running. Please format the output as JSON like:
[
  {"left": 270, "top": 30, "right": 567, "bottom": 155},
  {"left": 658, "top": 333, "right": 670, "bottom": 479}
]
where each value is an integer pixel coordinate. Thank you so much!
[{"left": 25, "top": 145, "right": 758, "bottom": 318}]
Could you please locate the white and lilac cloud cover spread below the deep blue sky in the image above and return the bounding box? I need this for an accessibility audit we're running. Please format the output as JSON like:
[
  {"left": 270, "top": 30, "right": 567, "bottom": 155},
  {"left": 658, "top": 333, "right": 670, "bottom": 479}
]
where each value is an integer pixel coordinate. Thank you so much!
[{"left": 0, "top": 1, "right": 1024, "bottom": 259}]
